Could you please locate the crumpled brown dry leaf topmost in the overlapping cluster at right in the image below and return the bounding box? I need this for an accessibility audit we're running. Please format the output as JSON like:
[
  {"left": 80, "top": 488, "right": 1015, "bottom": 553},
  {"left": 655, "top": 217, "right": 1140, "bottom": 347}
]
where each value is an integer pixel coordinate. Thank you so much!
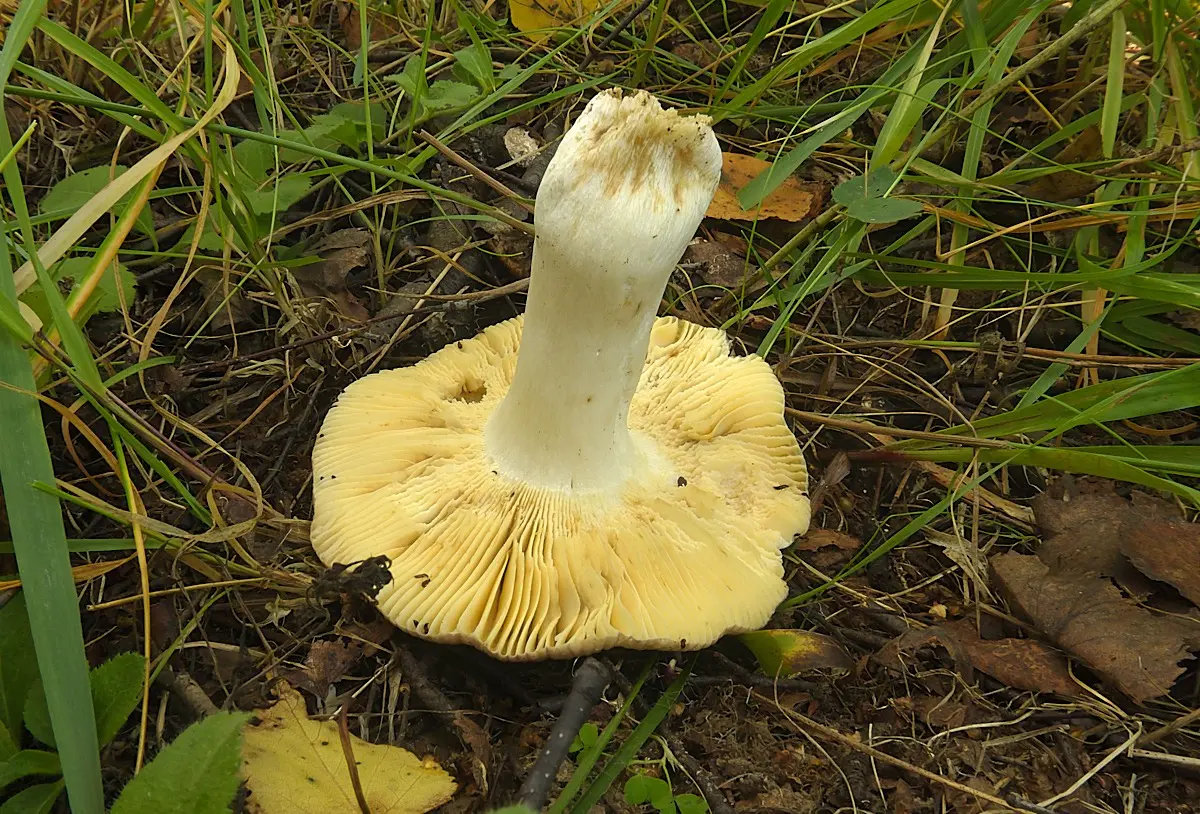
[{"left": 1033, "top": 483, "right": 1180, "bottom": 597}]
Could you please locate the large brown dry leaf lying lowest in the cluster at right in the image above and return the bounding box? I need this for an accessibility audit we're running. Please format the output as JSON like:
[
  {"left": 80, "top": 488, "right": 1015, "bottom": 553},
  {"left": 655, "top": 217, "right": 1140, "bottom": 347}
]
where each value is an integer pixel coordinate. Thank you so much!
[{"left": 991, "top": 553, "right": 1188, "bottom": 702}]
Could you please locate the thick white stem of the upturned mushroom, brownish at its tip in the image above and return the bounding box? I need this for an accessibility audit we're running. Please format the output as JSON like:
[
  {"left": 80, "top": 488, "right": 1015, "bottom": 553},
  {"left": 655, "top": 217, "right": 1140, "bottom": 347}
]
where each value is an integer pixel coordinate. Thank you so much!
[{"left": 486, "top": 91, "right": 721, "bottom": 491}]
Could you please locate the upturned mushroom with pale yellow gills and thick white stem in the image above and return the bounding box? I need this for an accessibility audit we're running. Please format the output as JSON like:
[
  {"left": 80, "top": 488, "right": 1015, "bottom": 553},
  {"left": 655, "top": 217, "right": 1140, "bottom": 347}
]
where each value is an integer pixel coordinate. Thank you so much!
[{"left": 311, "top": 90, "right": 810, "bottom": 660}]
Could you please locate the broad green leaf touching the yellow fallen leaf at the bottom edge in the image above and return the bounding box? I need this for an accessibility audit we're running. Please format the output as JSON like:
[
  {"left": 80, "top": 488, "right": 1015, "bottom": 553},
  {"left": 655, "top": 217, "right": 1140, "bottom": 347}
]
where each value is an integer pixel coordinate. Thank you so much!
[{"left": 110, "top": 712, "right": 250, "bottom": 814}]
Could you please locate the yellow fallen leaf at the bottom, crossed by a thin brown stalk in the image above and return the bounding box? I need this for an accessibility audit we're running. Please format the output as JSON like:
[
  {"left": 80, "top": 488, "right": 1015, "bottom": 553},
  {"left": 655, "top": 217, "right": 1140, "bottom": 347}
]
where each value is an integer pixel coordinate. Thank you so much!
[{"left": 242, "top": 684, "right": 457, "bottom": 814}]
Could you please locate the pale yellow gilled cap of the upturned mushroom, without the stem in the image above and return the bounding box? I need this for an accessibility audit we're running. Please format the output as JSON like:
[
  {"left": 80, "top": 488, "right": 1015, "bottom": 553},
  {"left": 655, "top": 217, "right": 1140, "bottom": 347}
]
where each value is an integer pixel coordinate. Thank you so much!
[{"left": 311, "top": 317, "right": 810, "bottom": 660}]
